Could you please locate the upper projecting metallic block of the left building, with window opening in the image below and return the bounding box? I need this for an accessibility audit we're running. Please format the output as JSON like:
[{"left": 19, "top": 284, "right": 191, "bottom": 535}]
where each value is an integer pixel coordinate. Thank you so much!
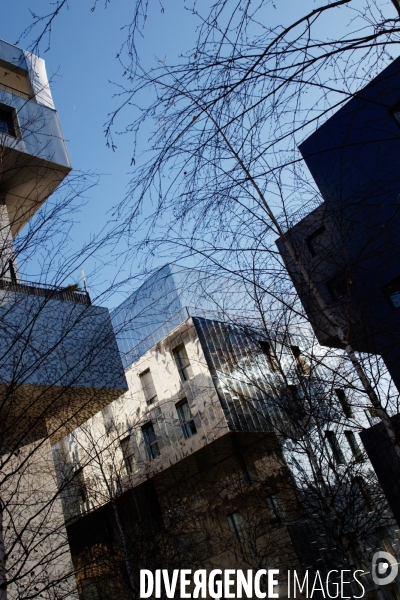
[{"left": 0, "top": 40, "right": 71, "bottom": 236}]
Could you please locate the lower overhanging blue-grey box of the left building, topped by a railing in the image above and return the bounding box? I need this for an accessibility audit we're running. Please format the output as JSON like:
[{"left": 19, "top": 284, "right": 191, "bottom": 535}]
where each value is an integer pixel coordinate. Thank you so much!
[{"left": 0, "top": 279, "right": 127, "bottom": 448}]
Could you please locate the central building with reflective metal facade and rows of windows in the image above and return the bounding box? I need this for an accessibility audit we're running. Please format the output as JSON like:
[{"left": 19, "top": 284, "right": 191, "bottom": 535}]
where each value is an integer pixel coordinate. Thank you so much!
[{"left": 53, "top": 266, "right": 398, "bottom": 599}]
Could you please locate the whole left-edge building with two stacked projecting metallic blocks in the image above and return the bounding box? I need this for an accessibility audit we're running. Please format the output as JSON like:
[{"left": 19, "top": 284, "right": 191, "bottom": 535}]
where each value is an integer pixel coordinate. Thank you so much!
[{"left": 0, "top": 41, "right": 127, "bottom": 598}]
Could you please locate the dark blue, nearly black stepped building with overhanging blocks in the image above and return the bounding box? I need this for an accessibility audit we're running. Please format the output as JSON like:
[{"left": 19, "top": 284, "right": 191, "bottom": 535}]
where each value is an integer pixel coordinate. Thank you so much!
[{"left": 277, "top": 59, "right": 400, "bottom": 390}]
